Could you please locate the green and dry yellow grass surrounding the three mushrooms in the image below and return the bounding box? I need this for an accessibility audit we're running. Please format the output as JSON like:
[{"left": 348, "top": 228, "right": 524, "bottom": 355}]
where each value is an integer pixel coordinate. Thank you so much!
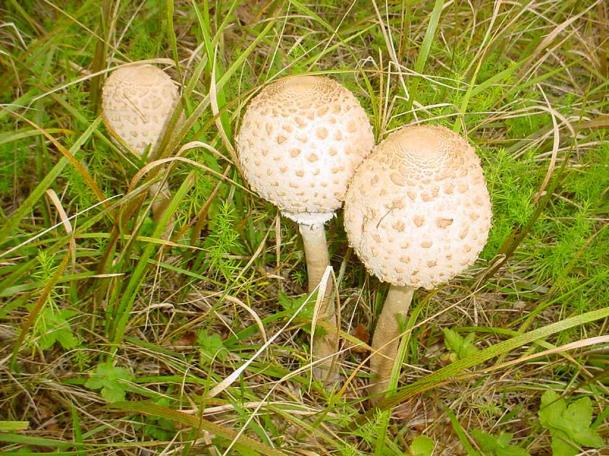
[{"left": 0, "top": 0, "right": 609, "bottom": 456}]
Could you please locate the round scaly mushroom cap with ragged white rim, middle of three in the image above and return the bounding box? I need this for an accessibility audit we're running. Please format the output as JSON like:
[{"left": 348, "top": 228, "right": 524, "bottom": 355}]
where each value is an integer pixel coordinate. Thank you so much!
[{"left": 237, "top": 76, "right": 374, "bottom": 224}]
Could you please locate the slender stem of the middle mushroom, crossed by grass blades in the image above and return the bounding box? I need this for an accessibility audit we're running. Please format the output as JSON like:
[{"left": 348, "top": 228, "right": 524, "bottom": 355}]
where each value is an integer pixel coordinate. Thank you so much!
[{"left": 298, "top": 223, "right": 338, "bottom": 384}]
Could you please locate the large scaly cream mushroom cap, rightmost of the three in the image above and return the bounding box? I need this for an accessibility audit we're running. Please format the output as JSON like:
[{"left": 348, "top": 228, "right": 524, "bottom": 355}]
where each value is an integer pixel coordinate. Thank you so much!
[{"left": 345, "top": 126, "right": 492, "bottom": 289}]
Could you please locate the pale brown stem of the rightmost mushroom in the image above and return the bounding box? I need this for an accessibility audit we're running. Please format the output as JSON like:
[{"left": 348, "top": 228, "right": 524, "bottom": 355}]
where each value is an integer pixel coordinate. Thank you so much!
[{"left": 369, "top": 286, "right": 414, "bottom": 402}]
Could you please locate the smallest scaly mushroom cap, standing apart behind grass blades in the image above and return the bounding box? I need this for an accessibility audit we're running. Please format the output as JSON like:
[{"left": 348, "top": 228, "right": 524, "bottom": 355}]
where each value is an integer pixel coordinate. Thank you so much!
[{"left": 102, "top": 64, "right": 178, "bottom": 155}]
